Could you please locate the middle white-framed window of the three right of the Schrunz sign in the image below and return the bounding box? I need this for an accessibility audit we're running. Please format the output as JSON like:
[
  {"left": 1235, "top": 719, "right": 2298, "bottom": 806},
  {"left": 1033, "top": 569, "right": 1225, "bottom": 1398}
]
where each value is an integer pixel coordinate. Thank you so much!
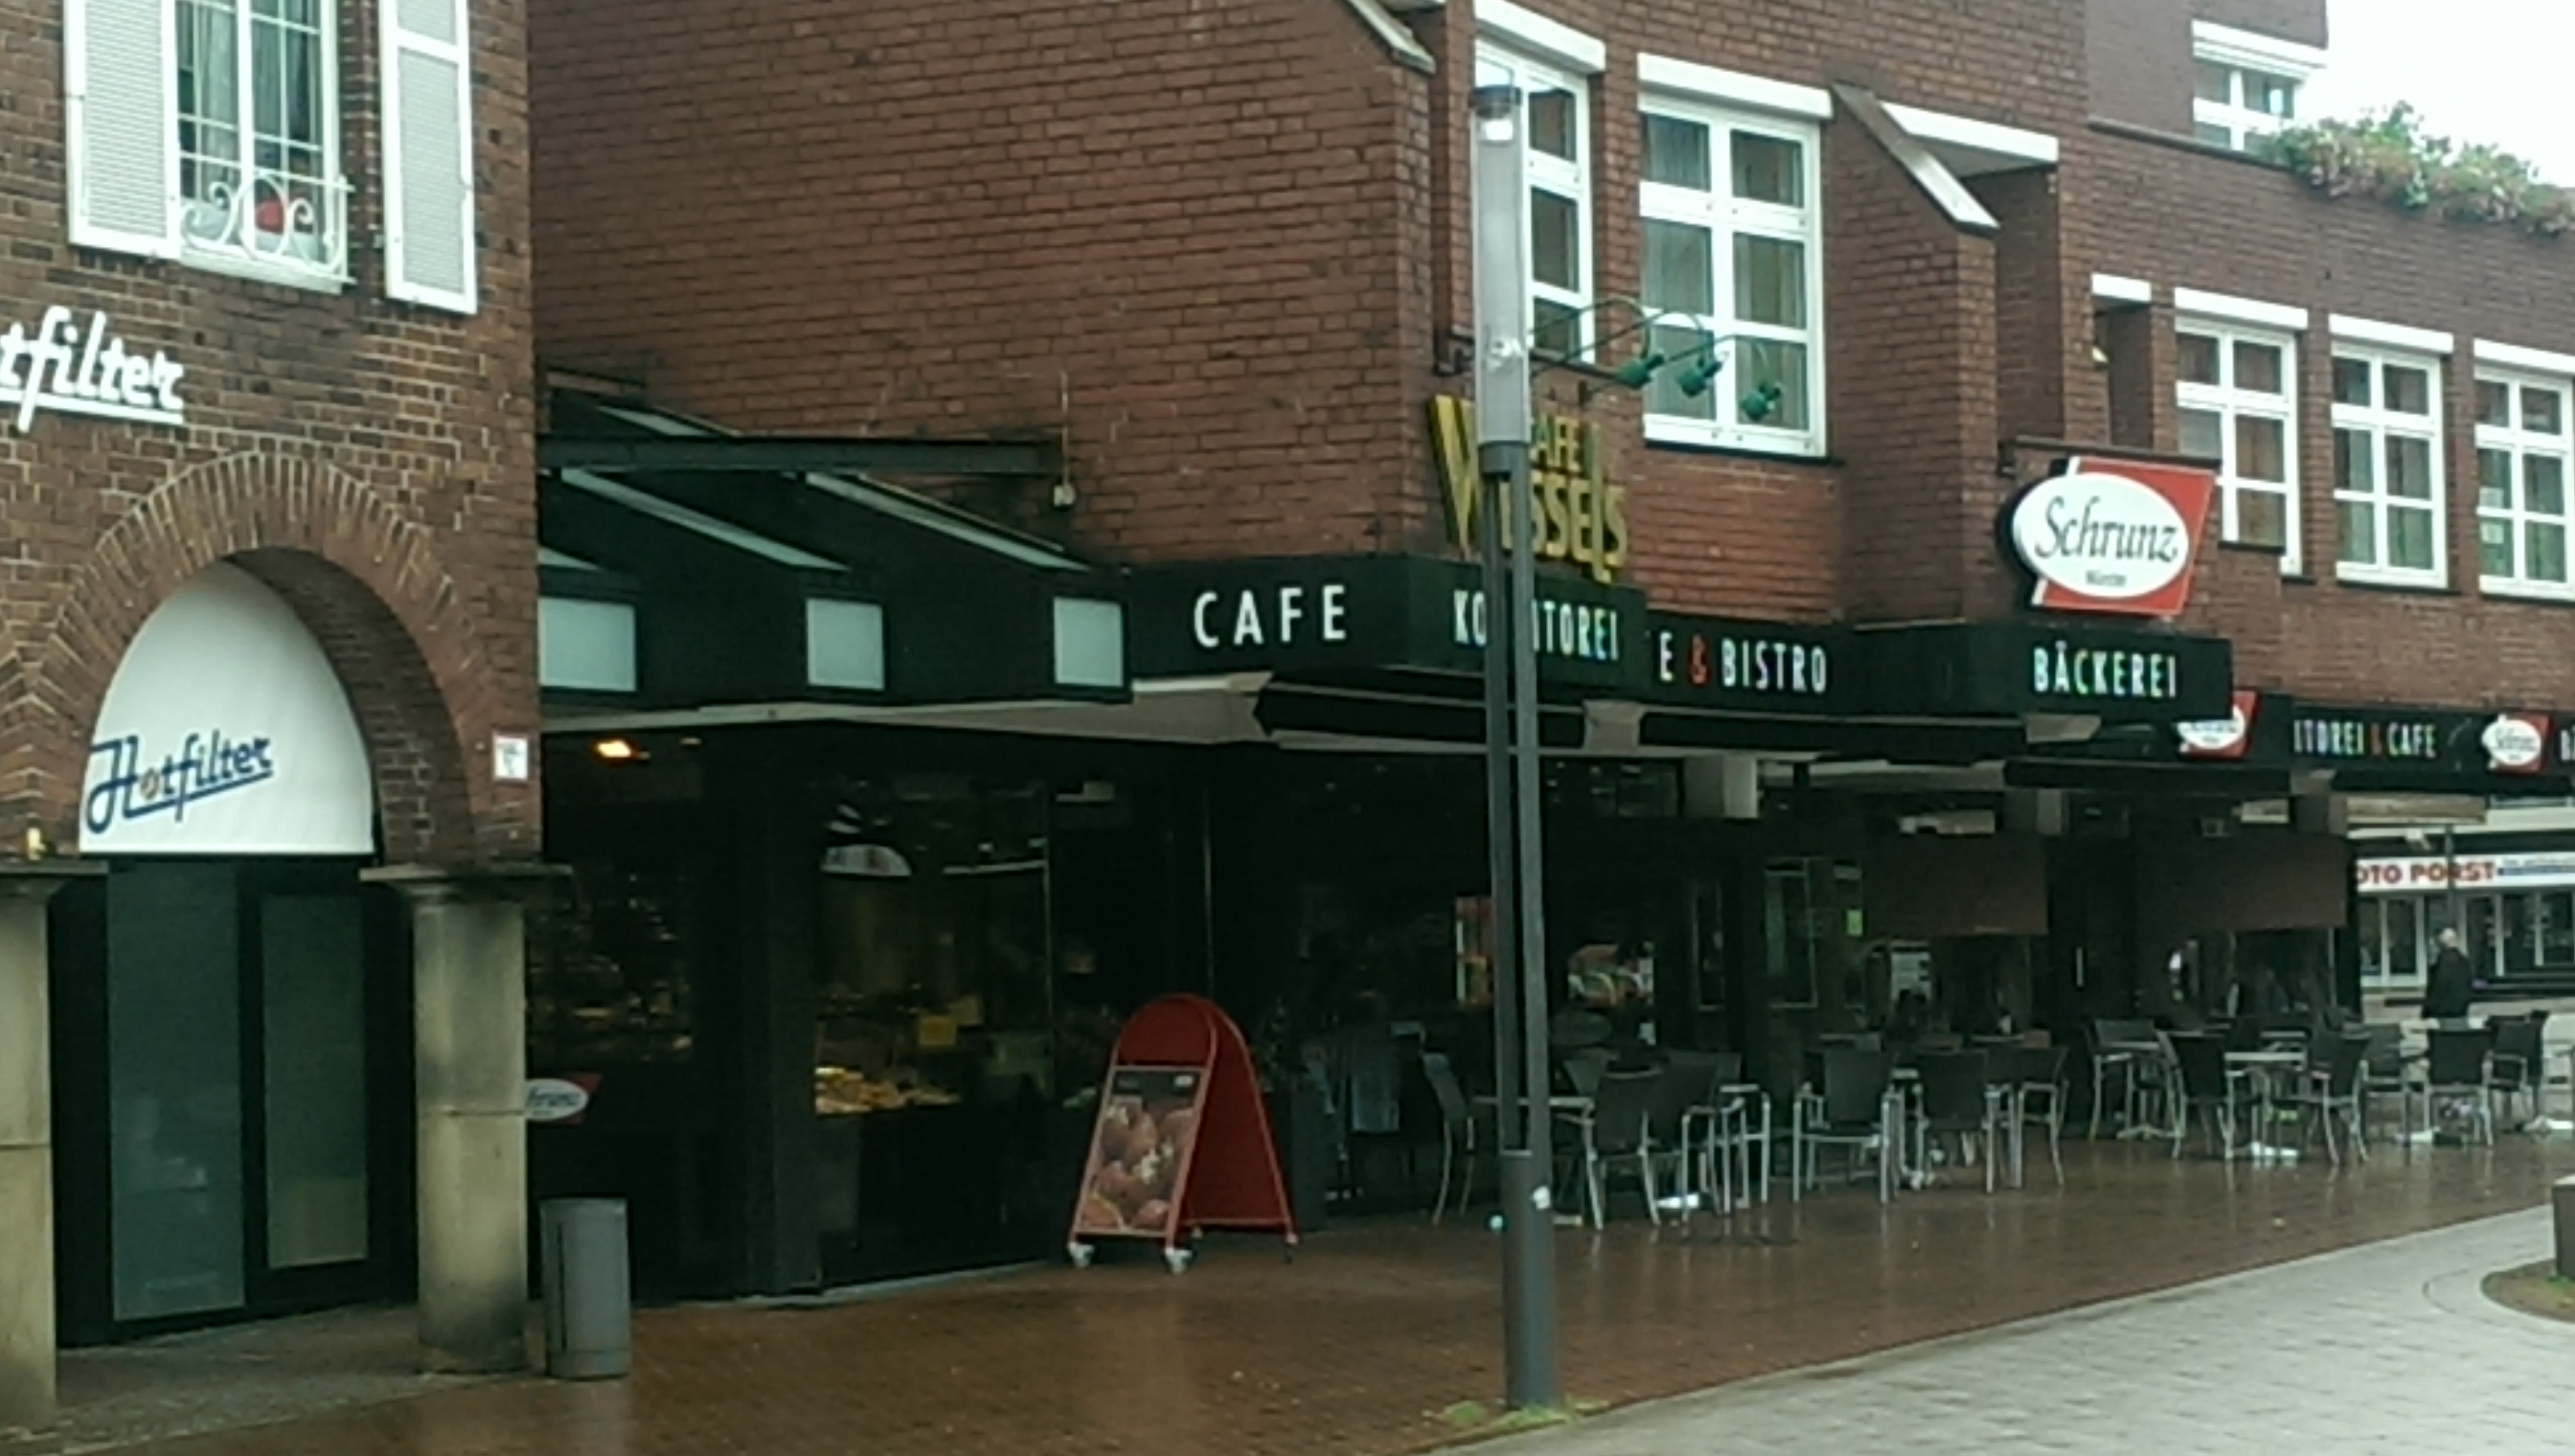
[{"left": 2333, "top": 348, "right": 2449, "bottom": 585}]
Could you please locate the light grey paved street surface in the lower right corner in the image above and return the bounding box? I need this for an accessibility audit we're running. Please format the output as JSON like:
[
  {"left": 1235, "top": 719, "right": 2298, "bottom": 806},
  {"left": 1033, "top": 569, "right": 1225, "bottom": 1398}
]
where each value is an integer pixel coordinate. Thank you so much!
[{"left": 1486, "top": 1211, "right": 2575, "bottom": 1456}]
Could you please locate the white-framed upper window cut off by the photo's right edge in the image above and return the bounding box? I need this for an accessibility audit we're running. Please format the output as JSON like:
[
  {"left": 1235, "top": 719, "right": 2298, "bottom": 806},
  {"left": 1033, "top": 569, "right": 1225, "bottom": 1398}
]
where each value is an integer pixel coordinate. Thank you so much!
[{"left": 2477, "top": 374, "right": 2575, "bottom": 595}]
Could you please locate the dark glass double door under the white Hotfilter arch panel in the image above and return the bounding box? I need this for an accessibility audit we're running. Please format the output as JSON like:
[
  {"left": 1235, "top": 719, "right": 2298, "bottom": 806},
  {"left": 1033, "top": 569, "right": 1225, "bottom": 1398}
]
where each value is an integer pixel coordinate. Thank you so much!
[{"left": 75, "top": 861, "right": 394, "bottom": 1340}]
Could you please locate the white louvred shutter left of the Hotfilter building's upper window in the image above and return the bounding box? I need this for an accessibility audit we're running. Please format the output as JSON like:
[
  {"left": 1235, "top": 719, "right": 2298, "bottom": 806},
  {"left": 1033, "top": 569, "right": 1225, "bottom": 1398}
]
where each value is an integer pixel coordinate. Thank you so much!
[{"left": 62, "top": 0, "right": 177, "bottom": 258}]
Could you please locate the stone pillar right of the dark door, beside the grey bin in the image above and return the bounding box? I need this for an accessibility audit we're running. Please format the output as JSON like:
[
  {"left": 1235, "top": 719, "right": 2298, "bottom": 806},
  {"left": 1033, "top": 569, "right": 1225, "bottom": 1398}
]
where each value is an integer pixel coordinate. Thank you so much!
[{"left": 366, "top": 866, "right": 554, "bottom": 1371}]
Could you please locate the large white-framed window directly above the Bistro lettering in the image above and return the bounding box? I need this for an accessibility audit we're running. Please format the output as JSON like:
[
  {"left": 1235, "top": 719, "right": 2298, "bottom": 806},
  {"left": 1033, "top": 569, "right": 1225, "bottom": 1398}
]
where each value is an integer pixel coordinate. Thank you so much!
[{"left": 1638, "top": 96, "right": 1823, "bottom": 453}]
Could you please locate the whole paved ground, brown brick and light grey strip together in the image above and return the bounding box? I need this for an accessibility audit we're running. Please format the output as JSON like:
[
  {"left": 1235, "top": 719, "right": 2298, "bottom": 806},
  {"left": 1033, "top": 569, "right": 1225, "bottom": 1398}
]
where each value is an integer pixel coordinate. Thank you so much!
[{"left": 20, "top": 1136, "right": 2575, "bottom": 1456}]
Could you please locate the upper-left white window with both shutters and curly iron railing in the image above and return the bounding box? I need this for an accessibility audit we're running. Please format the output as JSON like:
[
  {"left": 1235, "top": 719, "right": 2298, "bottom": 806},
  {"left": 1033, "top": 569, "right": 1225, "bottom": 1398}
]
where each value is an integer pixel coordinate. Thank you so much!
[{"left": 62, "top": 0, "right": 474, "bottom": 312}]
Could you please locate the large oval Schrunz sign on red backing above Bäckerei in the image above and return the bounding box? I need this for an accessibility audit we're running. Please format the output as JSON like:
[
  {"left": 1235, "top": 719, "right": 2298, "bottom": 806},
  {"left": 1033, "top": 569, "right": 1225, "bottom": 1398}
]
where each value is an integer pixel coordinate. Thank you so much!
[{"left": 2009, "top": 459, "right": 2217, "bottom": 616}]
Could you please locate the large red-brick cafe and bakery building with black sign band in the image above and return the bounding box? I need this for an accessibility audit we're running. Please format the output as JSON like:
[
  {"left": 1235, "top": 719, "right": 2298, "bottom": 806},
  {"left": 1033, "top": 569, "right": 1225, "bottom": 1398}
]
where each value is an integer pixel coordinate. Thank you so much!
[{"left": 512, "top": 0, "right": 2575, "bottom": 1285}]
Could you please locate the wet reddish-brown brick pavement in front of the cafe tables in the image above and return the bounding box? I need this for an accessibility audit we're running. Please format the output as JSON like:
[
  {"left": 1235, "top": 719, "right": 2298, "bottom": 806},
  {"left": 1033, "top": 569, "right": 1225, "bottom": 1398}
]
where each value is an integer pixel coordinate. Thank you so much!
[{"left": 20, "top": 1136, "right": 2575, "bottom": 1456}]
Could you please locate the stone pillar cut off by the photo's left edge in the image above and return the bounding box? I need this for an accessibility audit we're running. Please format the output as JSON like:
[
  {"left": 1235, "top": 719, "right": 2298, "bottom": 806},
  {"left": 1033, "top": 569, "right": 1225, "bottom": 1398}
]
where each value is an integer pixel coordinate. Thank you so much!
[{"left": 0, "top": 861, "right": 105, "bottom": 1430}]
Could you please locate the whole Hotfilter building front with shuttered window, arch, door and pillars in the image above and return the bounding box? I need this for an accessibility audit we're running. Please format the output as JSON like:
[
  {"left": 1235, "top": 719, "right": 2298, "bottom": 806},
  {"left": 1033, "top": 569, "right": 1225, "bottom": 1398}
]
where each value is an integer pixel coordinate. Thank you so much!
[{"left": 0, "top": 0, "right": 540, "bottom": 1425}]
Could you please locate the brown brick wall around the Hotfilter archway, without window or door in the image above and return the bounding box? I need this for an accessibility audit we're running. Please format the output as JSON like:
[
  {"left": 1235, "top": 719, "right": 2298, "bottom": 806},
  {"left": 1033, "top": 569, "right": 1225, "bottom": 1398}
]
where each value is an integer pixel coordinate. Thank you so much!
[{"left": 0, "top": 0, "right": 538, "bottom": 861}]
